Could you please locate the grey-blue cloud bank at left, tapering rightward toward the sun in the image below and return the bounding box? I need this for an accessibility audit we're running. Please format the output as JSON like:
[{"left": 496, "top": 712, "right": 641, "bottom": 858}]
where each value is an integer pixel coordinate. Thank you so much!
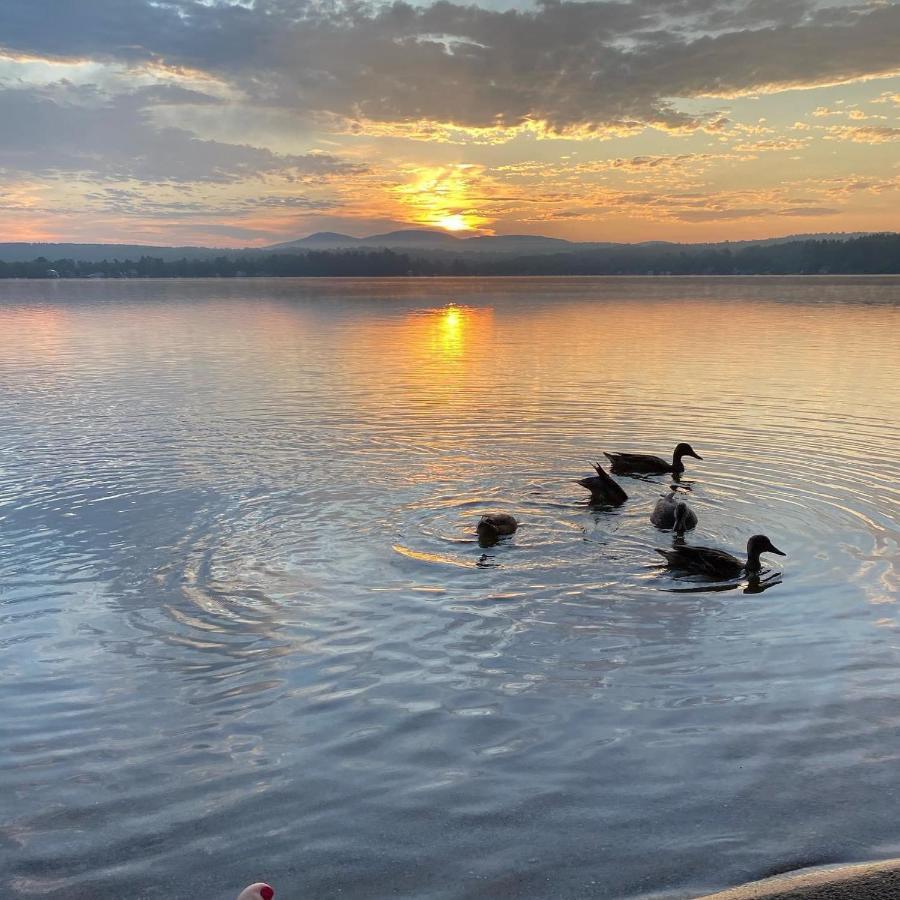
[{"left": 0, "top": 83, "right": 360, "bottom": 183}]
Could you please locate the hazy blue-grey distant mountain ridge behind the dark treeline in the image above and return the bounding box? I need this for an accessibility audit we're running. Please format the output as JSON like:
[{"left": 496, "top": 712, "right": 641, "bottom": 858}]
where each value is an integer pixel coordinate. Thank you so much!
[{"left": 0, "top": 229, "right": 873, "bottom": 262}]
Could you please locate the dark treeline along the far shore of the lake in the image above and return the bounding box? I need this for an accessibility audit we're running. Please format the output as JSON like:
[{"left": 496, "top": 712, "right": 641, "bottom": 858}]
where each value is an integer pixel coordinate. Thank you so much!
[{"left": 0, "top": 234, "right": 900, "bottom": 278}]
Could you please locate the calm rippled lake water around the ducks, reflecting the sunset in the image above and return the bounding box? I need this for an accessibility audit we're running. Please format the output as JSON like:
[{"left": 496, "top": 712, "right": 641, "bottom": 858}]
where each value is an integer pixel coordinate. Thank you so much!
[{"left": 0, "top": 278, "right": 900, "bottom": 900}]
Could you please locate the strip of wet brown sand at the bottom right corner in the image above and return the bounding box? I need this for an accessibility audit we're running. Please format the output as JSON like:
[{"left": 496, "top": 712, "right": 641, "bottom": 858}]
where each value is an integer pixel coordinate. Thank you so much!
[{"left": 698, "top": 859, "right": 900, "bottom": 900}]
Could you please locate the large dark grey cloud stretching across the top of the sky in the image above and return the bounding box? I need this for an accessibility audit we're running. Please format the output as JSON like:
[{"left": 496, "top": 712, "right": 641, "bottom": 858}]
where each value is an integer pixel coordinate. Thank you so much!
[{"left": 0, "top": 0, "right": 900, "bottom": 130}]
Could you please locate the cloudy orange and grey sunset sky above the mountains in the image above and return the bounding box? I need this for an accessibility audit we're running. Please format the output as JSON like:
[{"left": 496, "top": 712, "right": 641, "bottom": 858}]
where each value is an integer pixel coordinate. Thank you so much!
[{"left": 0, "top": 0, "right": 900, "bottom": 246}]
